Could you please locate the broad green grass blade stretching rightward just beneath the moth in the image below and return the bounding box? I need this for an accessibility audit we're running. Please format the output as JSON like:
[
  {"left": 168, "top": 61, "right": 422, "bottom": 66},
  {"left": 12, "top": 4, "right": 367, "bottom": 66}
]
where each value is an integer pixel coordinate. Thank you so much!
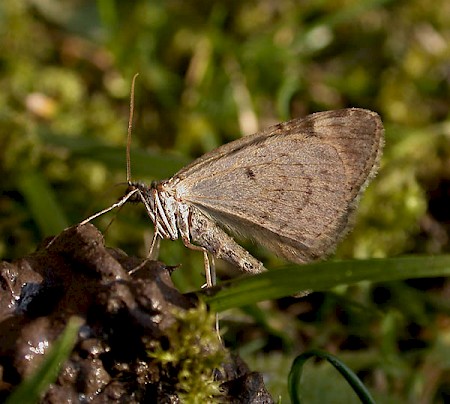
[{"left": 204, "top": 255, "right": 450, "bottom": 312}]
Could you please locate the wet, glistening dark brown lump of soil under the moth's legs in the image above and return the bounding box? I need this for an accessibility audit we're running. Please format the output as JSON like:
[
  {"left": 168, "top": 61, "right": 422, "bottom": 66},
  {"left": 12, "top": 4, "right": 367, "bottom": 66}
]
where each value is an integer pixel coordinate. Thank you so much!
[{"left": 0, "top": 224, "right": 273, "bottom": 403}]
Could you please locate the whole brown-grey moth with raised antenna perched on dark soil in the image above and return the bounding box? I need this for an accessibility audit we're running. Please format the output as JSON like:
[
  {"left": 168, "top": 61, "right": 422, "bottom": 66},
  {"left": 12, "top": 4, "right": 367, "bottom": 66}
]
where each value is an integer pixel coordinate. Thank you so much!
[{"left": 81, "top": 80, "right": 384, "bottom": 286}]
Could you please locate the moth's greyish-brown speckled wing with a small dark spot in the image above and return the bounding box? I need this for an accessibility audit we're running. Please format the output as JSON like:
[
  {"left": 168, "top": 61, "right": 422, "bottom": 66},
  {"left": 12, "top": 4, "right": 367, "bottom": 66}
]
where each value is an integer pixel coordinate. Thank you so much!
[{"left": 170, "top": 108, "right": 383, "bottom": 263}]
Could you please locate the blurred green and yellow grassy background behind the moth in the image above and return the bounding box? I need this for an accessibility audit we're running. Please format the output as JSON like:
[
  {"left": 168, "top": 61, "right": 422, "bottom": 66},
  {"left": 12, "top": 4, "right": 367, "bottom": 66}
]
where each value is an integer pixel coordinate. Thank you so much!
[{"left": 0, "top": 0, "right": 450, "bottom": 402}]
